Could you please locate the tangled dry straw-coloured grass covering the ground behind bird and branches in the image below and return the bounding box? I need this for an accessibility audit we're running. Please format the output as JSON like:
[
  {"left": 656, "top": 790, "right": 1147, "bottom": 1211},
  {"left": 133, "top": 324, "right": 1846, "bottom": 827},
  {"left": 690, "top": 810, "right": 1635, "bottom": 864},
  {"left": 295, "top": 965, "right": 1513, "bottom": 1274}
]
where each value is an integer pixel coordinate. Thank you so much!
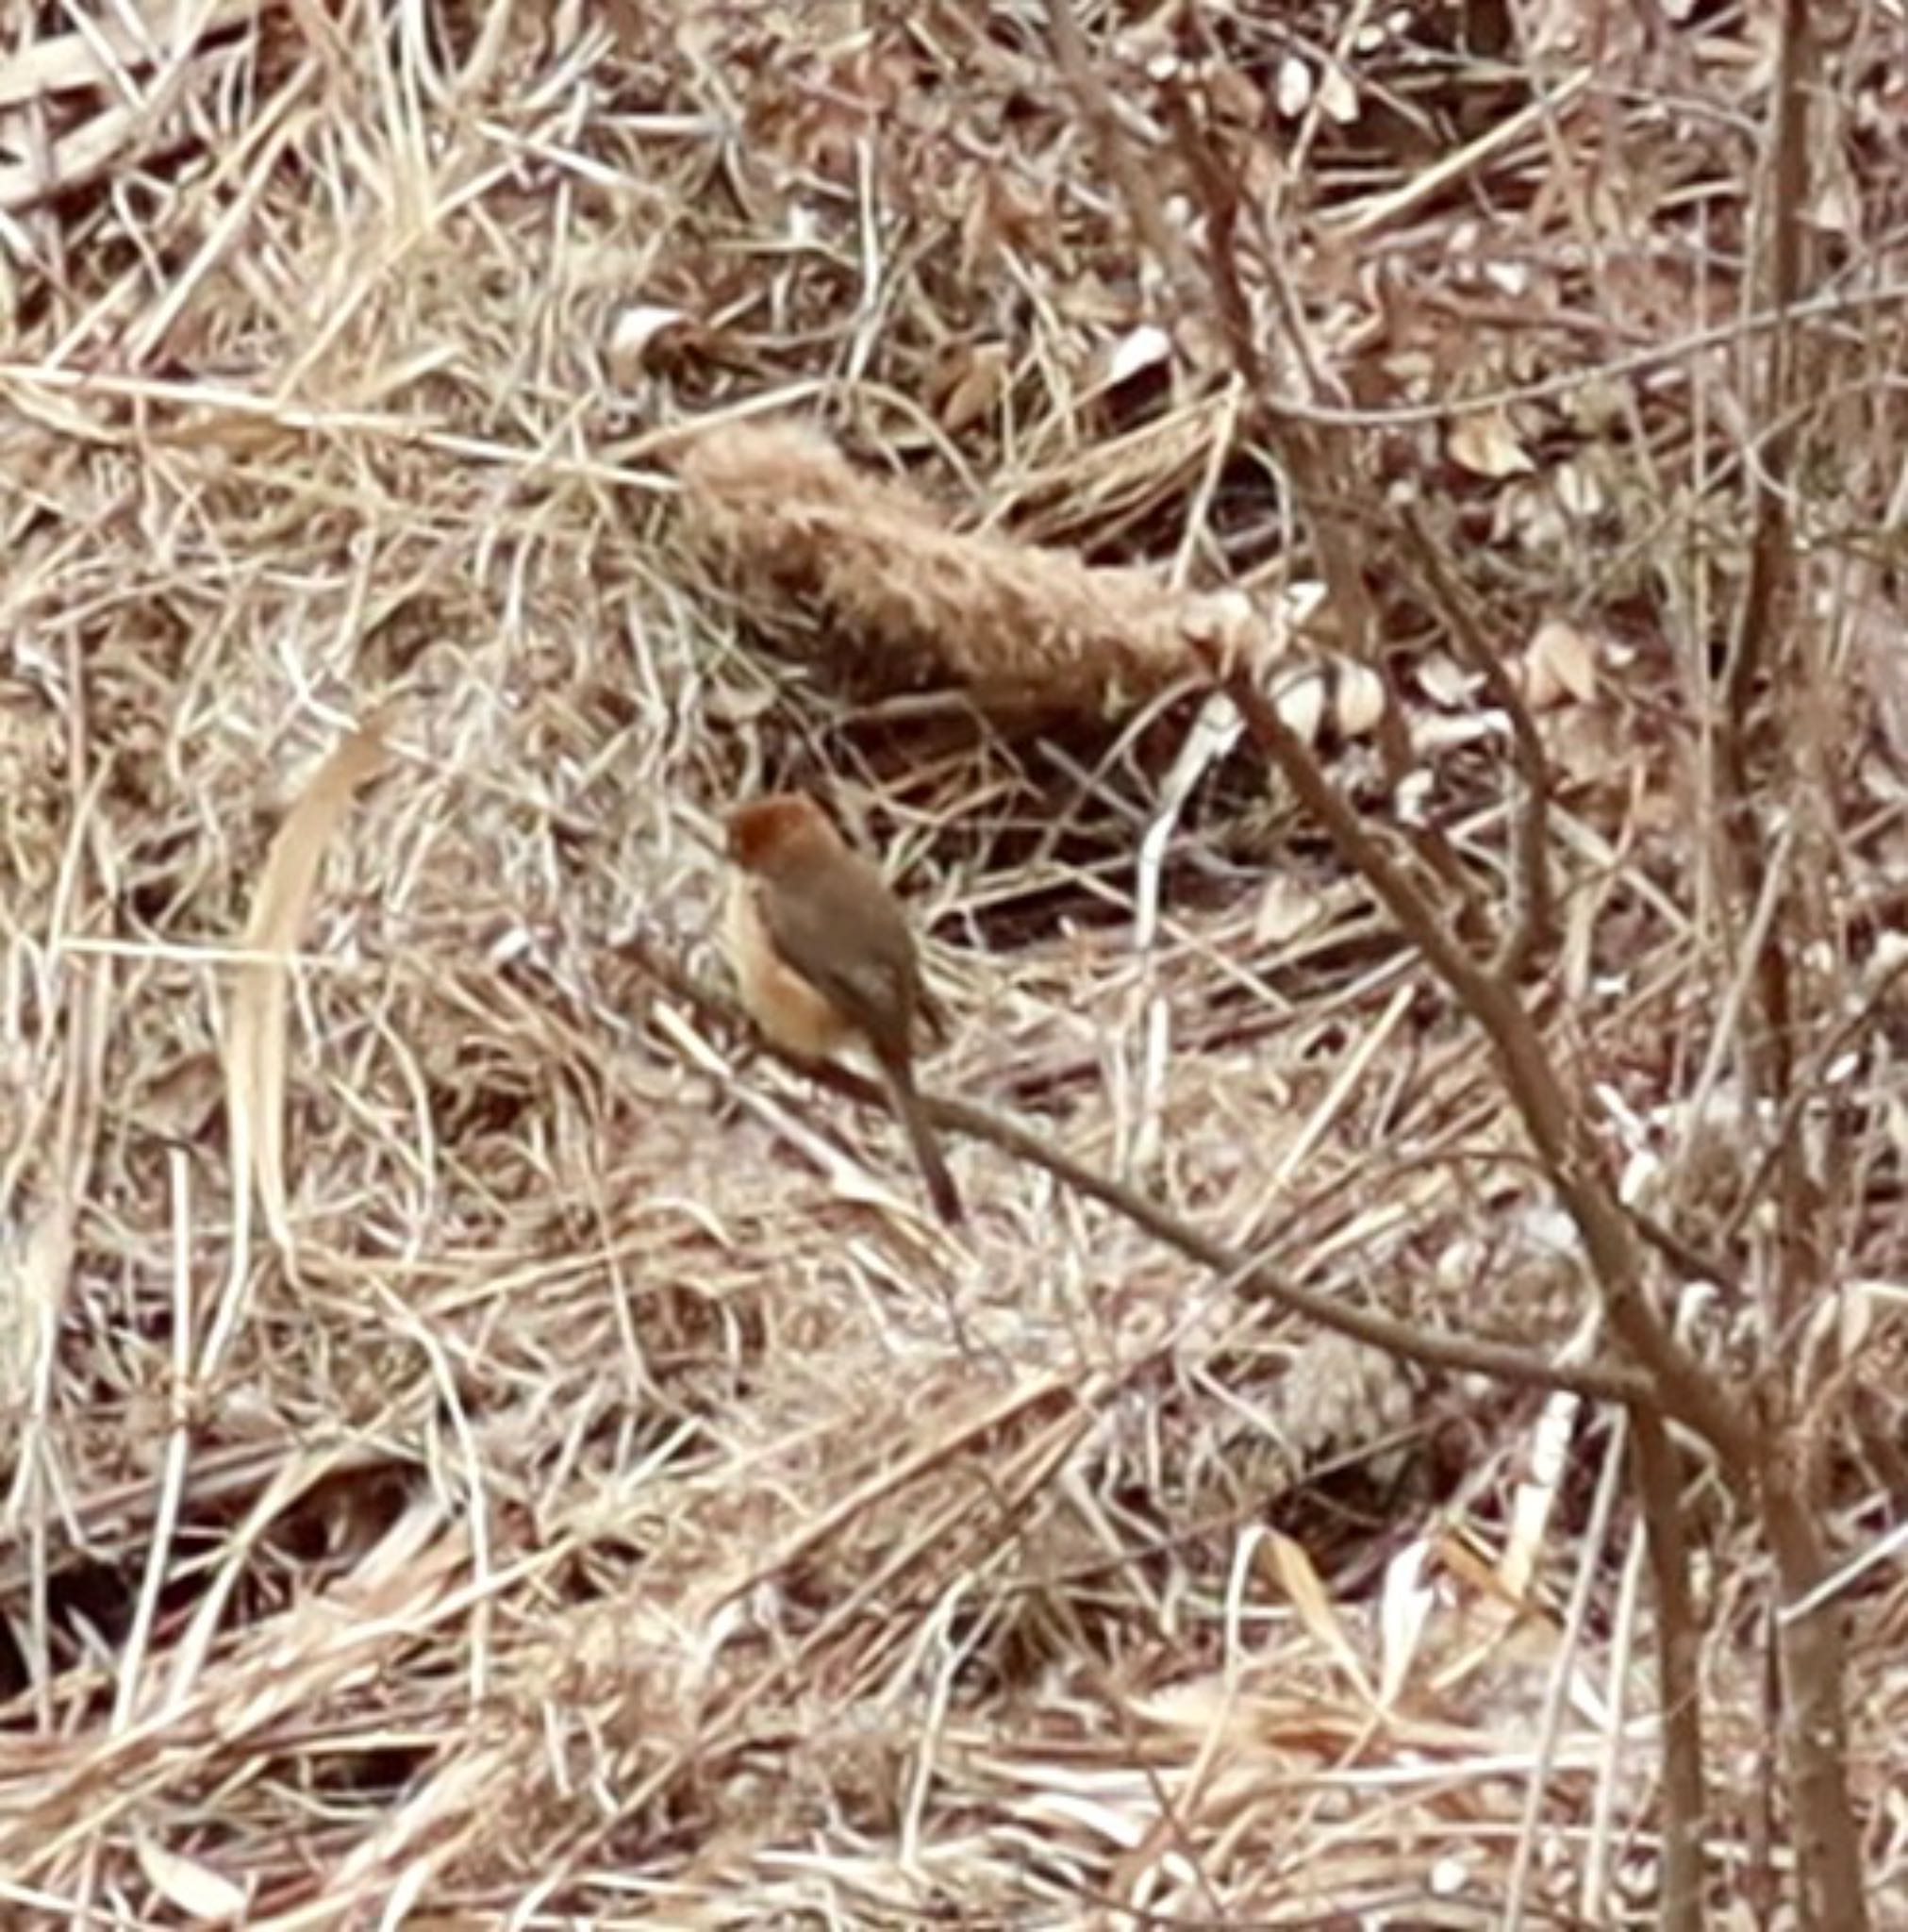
[{"left": 0, "top": 0, "right": 1908, "bottom": 1926}]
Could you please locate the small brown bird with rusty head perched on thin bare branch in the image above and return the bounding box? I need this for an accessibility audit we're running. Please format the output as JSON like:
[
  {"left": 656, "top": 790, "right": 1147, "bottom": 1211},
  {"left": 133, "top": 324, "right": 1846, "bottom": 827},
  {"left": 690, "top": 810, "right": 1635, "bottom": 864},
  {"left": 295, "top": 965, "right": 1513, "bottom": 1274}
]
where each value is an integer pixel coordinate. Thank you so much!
[{"left": 722, "top": 792, "right": 962, "bottom": 1223}]
